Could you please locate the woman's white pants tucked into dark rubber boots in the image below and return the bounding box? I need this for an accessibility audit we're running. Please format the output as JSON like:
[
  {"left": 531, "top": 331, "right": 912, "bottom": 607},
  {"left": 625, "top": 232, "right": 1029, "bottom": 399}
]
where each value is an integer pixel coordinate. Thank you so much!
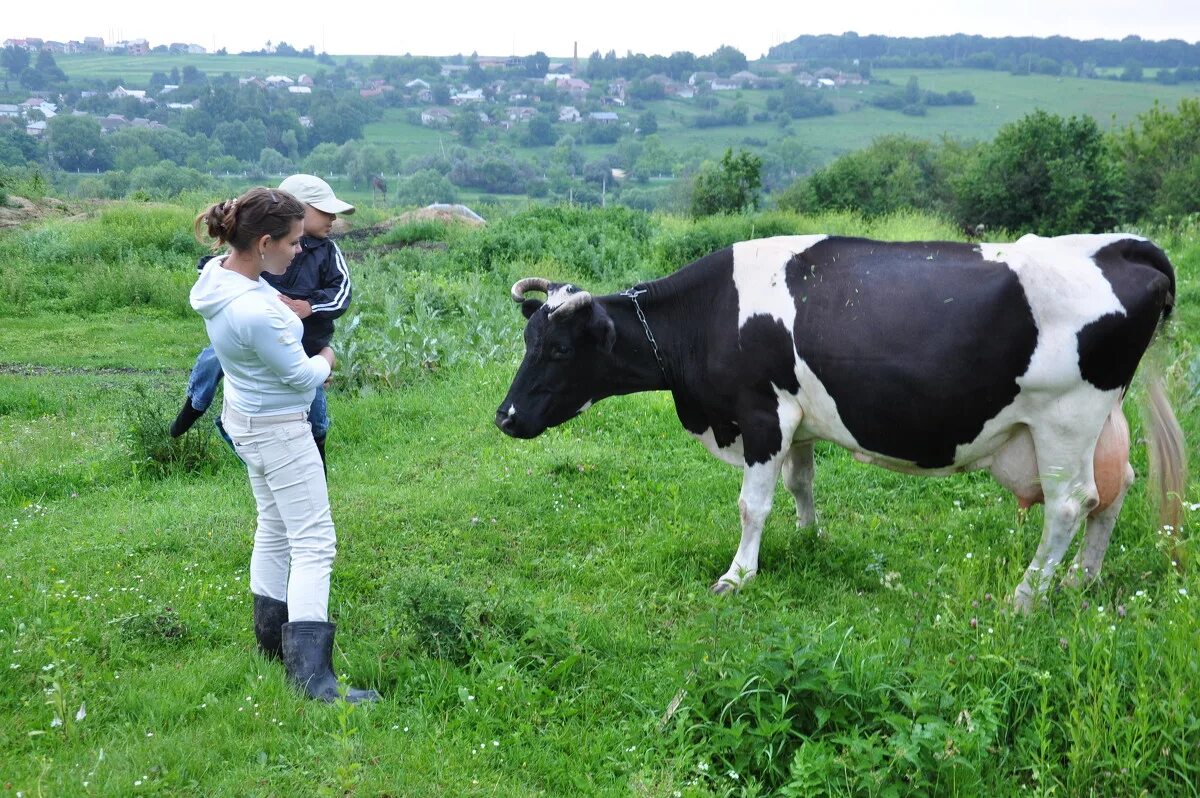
[{"left": 221, "top": 407, "right": 337, "bottom": 622}]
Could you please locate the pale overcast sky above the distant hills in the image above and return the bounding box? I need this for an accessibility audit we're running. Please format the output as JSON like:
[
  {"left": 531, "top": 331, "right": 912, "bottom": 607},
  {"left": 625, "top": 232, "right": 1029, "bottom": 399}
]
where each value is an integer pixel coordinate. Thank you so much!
[{"left": 0, "top": 0, "right": 1200, "bottom": 60}]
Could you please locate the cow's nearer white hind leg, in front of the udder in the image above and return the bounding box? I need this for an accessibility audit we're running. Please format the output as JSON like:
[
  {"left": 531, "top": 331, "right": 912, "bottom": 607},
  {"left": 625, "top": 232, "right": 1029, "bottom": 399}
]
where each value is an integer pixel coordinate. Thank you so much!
[{"left": 1013, "top": 408, "right": 1108, "bottom": 612}]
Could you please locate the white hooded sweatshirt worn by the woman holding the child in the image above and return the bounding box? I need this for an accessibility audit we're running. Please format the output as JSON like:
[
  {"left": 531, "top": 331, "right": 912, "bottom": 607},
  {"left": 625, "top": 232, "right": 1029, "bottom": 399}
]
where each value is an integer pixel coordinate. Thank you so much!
[{"left": 190, "top": 257, "right": 329, "bottom": 415}]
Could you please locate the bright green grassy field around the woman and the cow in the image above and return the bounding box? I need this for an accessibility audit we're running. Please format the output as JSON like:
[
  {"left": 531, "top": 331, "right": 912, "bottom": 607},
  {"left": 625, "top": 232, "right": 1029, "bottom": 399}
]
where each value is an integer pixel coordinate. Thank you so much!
[{"left": 0, "top": 200, "right": 1200, "bottom": 797}]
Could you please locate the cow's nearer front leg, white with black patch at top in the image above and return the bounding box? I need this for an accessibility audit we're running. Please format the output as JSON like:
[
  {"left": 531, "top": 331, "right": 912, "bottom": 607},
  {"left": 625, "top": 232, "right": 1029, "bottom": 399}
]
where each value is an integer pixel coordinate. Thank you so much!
[{"left": 712, "top": 402, "right": 800, "bottom": 593}]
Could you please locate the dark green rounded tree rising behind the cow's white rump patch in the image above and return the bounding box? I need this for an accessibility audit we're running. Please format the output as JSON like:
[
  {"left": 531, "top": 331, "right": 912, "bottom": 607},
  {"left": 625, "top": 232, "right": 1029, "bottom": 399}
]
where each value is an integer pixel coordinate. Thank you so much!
[{"left": 952, "top": 110, "right": 1120, "bottom": 235}]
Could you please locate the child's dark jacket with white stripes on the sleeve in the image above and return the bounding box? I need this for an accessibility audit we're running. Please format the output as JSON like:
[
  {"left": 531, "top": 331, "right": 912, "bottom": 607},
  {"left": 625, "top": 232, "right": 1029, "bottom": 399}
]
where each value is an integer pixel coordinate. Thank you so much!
[{"left": 196, "top": 235, "right": 350, "bottom": 358}]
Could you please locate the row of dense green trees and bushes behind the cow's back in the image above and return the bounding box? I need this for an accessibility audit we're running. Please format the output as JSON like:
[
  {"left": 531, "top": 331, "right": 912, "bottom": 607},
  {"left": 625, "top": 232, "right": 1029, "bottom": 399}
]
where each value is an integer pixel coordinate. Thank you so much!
[{"left": 776, "top": 98, "right": 1200, "bottom": 235}]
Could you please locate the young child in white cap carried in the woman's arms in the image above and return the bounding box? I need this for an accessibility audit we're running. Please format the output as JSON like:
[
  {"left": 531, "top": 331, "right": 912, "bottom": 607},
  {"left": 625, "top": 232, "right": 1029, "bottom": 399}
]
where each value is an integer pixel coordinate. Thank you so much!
[{"left": 170, "top": 174, "right": 354, "bottom": 462}]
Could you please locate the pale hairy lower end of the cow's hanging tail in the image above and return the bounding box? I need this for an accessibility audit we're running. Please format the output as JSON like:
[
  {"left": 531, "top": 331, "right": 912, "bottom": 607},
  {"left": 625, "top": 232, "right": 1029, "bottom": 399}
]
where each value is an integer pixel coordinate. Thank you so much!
[{"left": 1146, "top": 354, "right": 1188, "bottom": 571}]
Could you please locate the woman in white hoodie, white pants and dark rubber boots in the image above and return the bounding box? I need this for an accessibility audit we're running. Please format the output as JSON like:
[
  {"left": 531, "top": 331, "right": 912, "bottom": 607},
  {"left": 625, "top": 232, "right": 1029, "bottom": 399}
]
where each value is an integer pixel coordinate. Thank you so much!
[{"left": 191, "top": 188, "right": 379, "bottom": 702}]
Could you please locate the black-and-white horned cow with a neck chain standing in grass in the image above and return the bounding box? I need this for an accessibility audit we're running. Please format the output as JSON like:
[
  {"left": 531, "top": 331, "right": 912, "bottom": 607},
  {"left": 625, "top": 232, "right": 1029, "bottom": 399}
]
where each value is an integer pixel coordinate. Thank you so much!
[{"left": 496, "top": 234, "right": 1187, "bottom": 612}]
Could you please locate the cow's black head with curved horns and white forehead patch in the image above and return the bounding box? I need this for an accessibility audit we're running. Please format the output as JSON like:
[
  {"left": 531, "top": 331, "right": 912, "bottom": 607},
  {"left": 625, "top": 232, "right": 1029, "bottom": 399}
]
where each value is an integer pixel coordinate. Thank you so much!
[{"left": 496, "top": 277, "right": 617, "bottom": 438}]
